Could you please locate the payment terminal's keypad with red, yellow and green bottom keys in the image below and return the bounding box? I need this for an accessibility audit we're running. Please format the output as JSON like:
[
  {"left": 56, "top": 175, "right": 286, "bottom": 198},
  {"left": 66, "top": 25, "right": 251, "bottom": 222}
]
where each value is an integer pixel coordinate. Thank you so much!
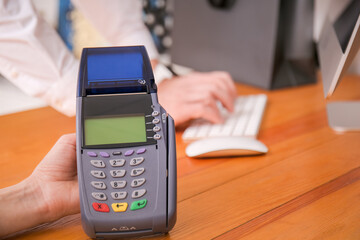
[{"left": 86, "top": 148, "right": 148, "bottom": 213}]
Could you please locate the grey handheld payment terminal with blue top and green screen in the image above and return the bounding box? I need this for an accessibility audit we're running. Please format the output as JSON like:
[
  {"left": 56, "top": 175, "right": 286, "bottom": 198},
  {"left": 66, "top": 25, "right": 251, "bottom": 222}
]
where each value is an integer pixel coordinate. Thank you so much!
[{"left": 76, "top": 46, "right": 176, "bottom": 239}]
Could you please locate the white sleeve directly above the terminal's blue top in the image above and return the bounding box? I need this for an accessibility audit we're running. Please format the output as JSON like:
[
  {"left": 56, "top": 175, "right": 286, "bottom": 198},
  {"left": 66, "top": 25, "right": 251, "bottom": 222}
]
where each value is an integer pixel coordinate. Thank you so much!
[{"left": 72, "top": 0, "right": 158, "bottom": 59}]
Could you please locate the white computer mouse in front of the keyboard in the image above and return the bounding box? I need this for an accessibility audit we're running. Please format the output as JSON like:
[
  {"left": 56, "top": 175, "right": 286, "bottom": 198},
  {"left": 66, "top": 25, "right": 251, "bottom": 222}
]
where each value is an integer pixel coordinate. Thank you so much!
[{"left": 185, "top": 137, "right": 268, "bottom": 158}]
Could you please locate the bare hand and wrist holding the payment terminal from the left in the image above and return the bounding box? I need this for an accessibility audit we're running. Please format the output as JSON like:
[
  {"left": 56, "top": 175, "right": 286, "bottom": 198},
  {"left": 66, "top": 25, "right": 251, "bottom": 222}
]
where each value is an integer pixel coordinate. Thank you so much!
[{"left": 0, "top": 134, "right": 80, "bottom": 237}]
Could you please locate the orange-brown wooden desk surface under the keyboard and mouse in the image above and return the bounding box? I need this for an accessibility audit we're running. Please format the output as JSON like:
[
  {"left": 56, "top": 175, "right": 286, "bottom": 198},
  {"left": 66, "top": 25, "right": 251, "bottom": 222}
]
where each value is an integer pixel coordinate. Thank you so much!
[{"left": 0, "top": 77, "right": 360, "bottom": 239}]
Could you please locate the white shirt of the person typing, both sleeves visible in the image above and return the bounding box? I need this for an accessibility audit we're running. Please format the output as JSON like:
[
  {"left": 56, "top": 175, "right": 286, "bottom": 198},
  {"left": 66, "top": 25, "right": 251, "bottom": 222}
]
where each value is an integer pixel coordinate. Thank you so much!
[{"left": 0, "top": 0, "right": 158, "bottom": 116}]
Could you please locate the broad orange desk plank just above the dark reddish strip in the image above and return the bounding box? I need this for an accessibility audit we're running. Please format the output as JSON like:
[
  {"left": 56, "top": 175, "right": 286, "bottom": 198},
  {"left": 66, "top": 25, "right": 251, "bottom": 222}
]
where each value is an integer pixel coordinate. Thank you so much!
[{"left": 153, "top": 136, "right": 360, "bottom": 239}]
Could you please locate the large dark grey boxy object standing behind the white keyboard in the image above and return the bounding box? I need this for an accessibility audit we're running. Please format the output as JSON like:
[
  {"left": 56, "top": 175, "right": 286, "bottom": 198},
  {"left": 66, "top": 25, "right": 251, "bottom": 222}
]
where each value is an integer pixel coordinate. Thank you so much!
[{"left": 170, "top": 0, "right": 317, "bottom": 89}]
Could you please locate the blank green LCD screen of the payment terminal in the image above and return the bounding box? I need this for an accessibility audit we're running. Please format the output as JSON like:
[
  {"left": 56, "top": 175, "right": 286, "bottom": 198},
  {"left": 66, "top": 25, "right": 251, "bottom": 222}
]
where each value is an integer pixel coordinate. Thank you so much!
[{"left": 84, "top": 116, "right": 146, "bottom": 146}]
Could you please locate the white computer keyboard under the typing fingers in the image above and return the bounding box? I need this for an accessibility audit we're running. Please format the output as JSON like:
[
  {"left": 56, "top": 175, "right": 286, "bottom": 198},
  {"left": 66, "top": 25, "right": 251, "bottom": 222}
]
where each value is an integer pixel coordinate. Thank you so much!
[{"left": 182, "top": 94, "right": 267, "bottom": 141}]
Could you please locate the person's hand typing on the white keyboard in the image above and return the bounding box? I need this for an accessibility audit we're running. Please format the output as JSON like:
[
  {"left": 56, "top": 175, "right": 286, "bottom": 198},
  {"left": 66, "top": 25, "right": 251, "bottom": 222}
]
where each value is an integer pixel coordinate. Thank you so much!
[{"left": 158, "top": 72, "right": 236, "bottom": 125}]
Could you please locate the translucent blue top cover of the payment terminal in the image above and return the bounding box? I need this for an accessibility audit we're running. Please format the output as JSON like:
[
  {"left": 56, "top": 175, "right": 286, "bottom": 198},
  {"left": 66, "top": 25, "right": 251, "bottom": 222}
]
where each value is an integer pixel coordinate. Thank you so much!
[{"left": 77, "top": 46, "right": 156, "bottom": 97}]
